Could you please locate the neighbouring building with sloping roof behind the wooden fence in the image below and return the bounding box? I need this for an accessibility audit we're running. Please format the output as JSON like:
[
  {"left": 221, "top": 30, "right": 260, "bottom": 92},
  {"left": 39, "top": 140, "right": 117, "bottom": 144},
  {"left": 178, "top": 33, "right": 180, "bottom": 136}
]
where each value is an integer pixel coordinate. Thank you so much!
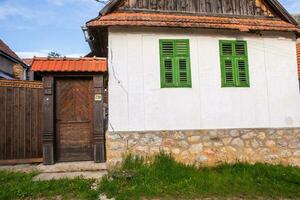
[{"left": 0, "top": 39, "right": 28, "bottom": 80}]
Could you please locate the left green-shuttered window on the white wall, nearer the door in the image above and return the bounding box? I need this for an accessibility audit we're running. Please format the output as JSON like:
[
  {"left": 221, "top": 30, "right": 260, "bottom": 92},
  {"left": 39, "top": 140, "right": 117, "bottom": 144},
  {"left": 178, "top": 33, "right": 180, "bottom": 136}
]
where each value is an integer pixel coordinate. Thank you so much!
[{"left": 159, "top": 39, "right": 192, "bottom": 88}]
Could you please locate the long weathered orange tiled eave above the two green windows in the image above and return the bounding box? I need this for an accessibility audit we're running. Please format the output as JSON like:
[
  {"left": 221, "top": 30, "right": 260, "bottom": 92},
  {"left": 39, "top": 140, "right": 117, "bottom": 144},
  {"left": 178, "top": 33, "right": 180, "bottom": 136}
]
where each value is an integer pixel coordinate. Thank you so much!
[{"left": 87, "top": 12, "right": 300, "bottom": 33}]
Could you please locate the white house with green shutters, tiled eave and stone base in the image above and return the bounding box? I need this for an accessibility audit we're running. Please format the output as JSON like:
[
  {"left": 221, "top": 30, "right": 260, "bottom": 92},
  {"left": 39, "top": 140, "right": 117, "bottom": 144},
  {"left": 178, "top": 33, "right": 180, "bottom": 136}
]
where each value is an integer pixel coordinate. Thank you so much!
[{"left": 87, "top": 0, "right": 300, "bottom": 165}]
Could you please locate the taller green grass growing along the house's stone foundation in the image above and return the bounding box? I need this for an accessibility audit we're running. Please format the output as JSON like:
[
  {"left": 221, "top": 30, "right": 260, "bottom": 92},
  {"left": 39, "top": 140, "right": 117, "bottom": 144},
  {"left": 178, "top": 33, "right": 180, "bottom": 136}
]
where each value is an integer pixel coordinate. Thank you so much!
[{"left": 99, "top": 154, "right": 300, "bottom": 200}]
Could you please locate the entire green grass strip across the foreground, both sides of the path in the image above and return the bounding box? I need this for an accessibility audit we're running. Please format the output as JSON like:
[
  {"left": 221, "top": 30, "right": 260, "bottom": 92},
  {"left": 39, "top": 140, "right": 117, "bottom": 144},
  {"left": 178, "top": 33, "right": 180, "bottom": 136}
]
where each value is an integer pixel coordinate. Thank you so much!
[{"left": 0, "top": 153, "right": 300, "bottom": 200}]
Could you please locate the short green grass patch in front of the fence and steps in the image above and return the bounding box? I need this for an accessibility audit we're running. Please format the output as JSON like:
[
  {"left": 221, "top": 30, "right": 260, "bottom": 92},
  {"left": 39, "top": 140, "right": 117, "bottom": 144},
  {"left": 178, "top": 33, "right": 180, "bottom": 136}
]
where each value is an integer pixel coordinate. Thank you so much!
[{"left": 0, "top": 171, "right": 98, "bottom": 200}]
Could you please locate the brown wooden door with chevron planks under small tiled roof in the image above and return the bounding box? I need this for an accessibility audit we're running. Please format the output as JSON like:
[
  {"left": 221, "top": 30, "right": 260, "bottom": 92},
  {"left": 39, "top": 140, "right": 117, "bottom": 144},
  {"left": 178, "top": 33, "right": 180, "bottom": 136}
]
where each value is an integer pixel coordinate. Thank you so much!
[{"left": 56, "top": 78, "right": 93, "bottom": 162}]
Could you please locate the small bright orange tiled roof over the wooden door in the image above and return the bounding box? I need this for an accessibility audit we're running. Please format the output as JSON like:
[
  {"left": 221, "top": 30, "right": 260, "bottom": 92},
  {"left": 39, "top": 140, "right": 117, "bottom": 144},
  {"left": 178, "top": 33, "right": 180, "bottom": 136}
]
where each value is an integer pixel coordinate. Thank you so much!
[{"left": 31, "top": 57, "right": 107, "bottom": 72}]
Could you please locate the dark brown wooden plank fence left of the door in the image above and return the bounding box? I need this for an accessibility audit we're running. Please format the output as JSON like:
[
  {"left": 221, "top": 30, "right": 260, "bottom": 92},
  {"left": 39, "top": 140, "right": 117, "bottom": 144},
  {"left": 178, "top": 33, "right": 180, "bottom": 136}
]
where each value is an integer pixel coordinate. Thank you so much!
[{"left": 0, "top": 80, "right": 43, "bottom": 164}]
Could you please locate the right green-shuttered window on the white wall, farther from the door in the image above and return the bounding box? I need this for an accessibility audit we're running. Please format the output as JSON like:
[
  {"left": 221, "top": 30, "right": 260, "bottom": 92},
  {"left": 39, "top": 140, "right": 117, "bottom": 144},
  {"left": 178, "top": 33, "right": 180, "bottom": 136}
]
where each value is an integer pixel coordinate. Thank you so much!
[{"left": 220, "top": 40, "right": 250, "bottom": 87}]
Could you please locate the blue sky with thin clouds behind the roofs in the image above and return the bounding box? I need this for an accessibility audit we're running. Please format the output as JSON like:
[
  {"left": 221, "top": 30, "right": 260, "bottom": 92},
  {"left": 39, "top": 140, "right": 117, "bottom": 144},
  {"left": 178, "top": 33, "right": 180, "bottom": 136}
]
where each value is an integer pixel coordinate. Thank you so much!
[{"left": 0, "top": 0, "right": 300, "bottom": 58}]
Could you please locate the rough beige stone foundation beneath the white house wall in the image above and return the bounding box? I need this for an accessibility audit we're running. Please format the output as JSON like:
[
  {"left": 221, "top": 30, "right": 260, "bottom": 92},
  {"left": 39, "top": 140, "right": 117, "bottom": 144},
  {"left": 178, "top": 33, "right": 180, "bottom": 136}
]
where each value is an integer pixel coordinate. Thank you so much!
[{"left": 106, "top": 128, "right": 300, "bottom": 166}]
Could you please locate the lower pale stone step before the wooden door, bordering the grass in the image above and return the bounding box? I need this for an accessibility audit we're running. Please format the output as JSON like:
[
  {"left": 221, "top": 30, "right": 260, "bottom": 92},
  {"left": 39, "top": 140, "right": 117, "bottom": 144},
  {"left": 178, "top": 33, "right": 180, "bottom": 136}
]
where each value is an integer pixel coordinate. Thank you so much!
[{"left": 32, "top": 170, "right": 107, "bottom": 181}]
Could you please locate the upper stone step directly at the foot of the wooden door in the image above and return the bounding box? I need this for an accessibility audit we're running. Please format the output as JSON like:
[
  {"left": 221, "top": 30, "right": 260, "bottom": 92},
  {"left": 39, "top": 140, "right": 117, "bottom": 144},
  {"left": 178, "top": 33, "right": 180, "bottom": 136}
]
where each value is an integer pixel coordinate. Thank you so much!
[{"left": 36, "top": 161, "right": 107, "bottom": 173}]
